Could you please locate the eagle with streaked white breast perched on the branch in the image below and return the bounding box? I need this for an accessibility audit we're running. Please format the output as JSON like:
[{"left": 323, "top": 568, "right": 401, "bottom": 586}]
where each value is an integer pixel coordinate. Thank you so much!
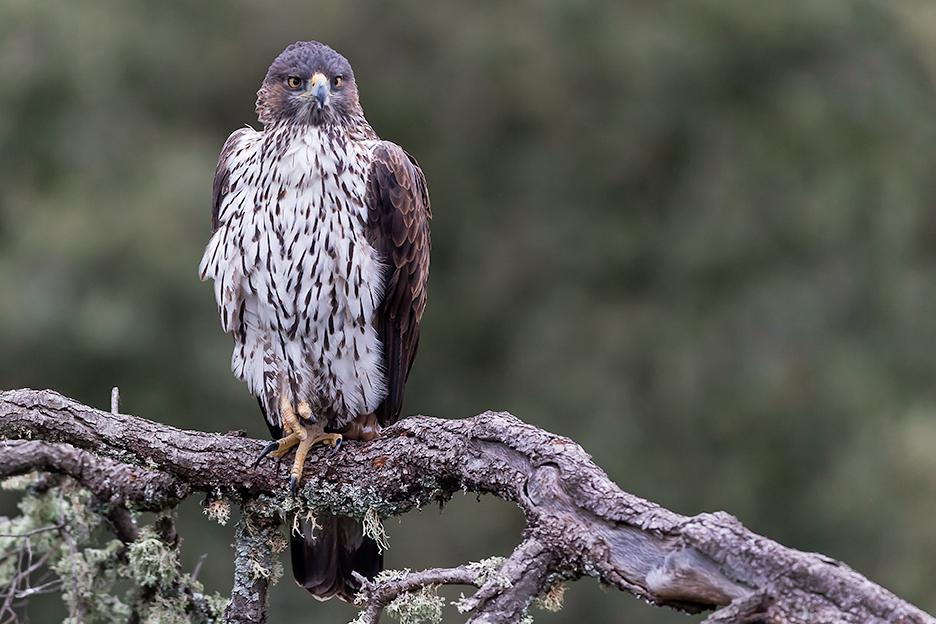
[{"left": 199, "top": 41, "right": 431, "bottom": 600}]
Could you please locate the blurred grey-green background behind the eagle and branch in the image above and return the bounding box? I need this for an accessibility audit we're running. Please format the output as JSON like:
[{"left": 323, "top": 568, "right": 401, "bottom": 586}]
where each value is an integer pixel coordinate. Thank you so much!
[{"left": 0, "top": 0, "right": 936, "bottom": 623}]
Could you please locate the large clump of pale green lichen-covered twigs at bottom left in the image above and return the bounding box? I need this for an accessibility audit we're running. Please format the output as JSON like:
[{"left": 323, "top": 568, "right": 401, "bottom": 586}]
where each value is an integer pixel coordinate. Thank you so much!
[{"left": 0, "top": 474, "right": 226, "bottom": 624}]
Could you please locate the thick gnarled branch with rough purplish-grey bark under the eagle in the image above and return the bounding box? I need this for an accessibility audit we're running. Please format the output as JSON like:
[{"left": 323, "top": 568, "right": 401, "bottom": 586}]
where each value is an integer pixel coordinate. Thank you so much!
[{"left": 0, "top": 390, "right": 936, "bottom": 624}]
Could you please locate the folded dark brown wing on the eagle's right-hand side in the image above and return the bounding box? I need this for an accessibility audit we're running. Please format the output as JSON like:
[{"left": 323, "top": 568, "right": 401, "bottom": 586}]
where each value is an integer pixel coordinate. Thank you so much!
[{"left": 365, "top": 142, "right": 432, "bottom": 426}]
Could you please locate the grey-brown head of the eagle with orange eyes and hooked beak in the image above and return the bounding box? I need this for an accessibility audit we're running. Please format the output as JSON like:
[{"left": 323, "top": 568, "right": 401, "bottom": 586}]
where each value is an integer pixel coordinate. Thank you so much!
[{"left": 257, "top": 41, "right": 362, "bottom": 126}]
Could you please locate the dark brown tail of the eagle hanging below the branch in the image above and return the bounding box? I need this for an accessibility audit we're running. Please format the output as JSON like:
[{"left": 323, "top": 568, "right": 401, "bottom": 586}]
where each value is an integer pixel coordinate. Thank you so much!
[{"left": 289, "top": 515, "right": 383, "bottom": 602}]
